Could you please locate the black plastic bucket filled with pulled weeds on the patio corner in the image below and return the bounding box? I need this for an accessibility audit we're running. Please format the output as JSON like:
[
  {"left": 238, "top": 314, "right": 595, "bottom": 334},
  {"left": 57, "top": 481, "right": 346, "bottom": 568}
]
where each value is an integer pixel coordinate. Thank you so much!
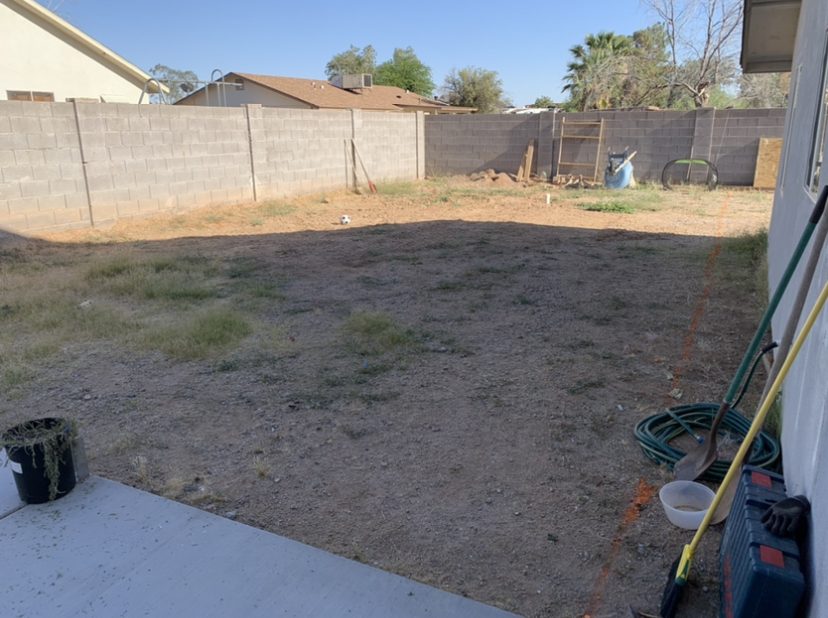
[{"left": 0, "top": 418, "right": 75, "bottom": 504}]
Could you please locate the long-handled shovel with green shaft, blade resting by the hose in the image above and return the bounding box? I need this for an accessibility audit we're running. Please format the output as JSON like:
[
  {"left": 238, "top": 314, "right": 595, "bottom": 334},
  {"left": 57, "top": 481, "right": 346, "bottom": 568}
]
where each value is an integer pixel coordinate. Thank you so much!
[{"left": 673, "top": 186, "right": 828, "bottom": 481}]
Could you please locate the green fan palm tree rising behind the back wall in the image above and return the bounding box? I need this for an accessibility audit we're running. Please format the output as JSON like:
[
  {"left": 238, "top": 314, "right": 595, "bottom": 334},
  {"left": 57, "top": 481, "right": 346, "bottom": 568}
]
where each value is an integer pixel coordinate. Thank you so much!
[{"left": 563, "top": 32, "right": 633, "bottom": 111}]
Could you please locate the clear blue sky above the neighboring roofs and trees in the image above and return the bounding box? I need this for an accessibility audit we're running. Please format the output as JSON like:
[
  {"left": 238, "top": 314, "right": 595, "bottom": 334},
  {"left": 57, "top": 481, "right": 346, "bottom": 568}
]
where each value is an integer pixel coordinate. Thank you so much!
[{"left": 50, "top": 0, "right": 655, "bottom": 105}]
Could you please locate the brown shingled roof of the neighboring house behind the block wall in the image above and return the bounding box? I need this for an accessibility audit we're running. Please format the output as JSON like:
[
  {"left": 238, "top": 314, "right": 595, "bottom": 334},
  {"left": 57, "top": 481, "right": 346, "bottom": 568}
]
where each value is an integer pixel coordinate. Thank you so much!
[{"left": 176, "top": 72, "right": 475, "bottom": 114}]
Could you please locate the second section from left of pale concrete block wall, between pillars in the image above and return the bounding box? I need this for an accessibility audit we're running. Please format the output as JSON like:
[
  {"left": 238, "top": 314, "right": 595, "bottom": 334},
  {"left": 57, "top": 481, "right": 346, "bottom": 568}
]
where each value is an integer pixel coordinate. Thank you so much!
[{"left": 77, "top": 103, "right": 253, "bottom": 224}]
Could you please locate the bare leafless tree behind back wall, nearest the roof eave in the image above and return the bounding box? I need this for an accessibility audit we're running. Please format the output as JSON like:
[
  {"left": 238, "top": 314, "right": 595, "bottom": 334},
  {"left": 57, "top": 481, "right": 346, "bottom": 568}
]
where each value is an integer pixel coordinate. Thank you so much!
[{"left": 646, "top": 0, "right": 743, "bottom": 107}]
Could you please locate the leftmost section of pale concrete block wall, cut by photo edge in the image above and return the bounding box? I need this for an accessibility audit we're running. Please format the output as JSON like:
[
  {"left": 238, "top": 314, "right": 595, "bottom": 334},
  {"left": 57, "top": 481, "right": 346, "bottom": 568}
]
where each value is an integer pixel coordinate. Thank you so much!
[{"left": 0, "top": 101, "right": 89, "bottom": 229}]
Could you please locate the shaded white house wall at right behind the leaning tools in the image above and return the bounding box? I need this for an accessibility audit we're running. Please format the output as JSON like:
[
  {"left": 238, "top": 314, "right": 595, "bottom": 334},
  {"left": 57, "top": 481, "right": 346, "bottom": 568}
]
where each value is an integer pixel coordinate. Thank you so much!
[{"left": 769, "top": 0, "right": 828, "bottom": 618}]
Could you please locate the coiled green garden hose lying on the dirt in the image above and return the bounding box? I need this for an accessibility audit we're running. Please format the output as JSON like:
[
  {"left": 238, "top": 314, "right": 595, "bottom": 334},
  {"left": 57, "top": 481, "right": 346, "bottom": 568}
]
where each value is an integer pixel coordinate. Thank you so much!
[{"left": 635, "top": 403, "right": 779, "bottom": 482}]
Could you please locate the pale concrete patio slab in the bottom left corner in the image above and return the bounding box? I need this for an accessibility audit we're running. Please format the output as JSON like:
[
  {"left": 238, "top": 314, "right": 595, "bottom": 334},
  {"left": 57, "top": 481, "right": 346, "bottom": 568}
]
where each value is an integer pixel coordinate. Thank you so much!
[{"left": 0, "top": 469, "right": 514, "bottom": 618}]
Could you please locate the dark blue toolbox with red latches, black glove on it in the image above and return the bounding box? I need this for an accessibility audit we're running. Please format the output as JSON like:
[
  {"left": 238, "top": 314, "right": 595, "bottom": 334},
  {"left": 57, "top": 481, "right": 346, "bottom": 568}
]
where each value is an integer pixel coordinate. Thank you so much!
[{"left": 719, "top": 466, "right": 805, "bottom": 618}]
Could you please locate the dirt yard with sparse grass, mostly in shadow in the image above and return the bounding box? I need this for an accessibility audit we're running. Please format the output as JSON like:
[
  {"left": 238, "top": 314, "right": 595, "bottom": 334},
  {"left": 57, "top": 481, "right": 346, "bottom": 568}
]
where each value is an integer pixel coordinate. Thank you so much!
[{"left": 0, "top": 179, "right": 772, "bottom": 618}]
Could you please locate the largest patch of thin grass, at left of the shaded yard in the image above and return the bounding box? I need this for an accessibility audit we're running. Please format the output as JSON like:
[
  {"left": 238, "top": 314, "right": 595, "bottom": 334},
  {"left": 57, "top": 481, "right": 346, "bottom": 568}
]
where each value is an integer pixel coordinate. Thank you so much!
[{"left": 0, "top": 243, "right": 280, "bottom": 391}]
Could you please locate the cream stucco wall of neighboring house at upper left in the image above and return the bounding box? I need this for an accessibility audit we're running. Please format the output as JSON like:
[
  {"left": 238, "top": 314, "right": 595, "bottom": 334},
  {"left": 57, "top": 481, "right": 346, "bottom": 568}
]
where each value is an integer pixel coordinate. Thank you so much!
[{"left": 0, "top": 0, "right": 142, "bottom": 103}]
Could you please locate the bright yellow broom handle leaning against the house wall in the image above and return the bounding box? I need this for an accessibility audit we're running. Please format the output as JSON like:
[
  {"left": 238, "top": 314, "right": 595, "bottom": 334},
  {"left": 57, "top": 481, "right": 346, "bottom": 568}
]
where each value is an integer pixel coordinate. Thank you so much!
[{"left": 676, "top": 282, "right": 828, "bottom": 581}]
